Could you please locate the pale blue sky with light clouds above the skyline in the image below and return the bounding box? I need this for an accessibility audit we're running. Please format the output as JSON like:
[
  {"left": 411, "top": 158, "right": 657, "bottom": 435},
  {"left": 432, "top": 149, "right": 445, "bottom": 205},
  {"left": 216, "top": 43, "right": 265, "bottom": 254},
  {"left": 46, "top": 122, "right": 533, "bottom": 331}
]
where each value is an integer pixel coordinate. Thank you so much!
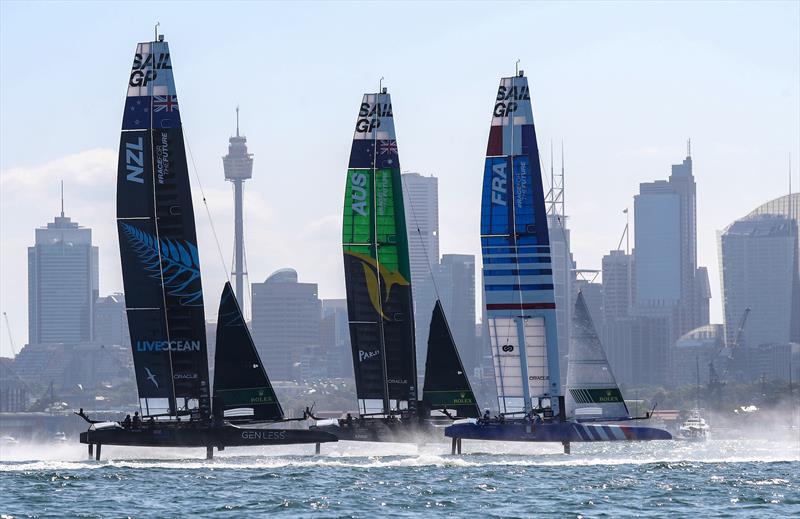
[{"left": 0, "top": 0, "right": 800, "bottom": 355}]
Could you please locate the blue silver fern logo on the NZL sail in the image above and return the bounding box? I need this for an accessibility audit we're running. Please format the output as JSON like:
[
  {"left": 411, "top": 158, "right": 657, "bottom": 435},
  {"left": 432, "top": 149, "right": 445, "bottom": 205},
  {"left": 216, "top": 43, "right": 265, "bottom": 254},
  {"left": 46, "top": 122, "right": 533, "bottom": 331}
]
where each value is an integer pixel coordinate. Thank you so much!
[{"left": 120, "top": 222, "right": 203, "bottom": 306}]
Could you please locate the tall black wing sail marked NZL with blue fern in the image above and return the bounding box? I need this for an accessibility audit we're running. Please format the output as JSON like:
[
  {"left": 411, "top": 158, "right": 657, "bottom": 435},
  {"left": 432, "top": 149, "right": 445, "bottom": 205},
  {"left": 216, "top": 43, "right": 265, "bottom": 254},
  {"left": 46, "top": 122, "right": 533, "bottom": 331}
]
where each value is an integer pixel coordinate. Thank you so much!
[{"left": 117, "top": 38, "right": 210, "bottom": 417}]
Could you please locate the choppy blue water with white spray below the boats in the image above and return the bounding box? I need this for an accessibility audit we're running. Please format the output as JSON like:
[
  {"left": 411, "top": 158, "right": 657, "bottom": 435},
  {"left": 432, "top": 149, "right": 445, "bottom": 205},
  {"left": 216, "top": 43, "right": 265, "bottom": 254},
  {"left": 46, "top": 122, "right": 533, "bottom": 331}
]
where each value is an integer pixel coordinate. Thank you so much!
[{"left": 0, "top": 438, "right": 800, "bottom": 518}]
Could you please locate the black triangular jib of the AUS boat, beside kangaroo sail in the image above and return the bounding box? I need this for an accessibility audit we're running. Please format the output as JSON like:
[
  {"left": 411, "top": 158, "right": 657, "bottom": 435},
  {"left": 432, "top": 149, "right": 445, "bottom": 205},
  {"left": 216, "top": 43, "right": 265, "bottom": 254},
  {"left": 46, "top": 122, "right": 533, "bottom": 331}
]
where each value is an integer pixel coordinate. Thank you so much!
[{"left": 422, "top": 299, "right": 481, "bottom": 418}]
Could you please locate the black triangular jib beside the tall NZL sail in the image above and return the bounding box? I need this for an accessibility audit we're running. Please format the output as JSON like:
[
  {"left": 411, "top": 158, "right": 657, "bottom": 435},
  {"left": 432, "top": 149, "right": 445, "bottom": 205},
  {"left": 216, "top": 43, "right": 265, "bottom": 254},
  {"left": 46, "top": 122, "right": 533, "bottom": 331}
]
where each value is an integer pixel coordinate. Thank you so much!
[{"left": 214, "top": 283, "right": 283, "bottom": 420}]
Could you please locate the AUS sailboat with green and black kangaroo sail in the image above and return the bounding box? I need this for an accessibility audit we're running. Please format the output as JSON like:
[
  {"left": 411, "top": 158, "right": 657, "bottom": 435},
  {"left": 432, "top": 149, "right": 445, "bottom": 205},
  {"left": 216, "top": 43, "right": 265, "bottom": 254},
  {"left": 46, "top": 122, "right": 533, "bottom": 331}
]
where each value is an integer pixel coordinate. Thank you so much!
[{"left": 316, "top": 87, "right": 475, "bottom": 442}]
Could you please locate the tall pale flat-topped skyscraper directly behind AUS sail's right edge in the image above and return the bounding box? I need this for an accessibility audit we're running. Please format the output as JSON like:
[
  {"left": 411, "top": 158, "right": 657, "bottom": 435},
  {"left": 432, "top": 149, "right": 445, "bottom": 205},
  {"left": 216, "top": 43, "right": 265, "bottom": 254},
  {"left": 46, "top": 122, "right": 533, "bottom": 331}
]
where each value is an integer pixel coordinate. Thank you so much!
[{"left": 402, "top": 173, "right": 439, "bottom": 381}]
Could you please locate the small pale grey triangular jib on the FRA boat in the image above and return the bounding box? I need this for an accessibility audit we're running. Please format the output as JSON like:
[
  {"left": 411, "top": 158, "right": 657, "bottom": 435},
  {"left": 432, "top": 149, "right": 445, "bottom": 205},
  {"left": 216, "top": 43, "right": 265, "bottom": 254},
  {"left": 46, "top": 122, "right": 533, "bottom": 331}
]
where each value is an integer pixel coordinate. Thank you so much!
[{"left": 565, "top": 292, "right": 630, "bottom": 420}]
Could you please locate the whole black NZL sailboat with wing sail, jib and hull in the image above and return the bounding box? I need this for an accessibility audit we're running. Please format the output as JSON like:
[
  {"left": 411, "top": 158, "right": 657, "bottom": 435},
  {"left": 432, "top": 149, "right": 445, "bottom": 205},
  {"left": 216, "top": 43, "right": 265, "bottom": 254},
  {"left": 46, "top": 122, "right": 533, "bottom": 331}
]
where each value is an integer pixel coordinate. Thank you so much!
[{"left": 78, "top": 36, "right": 336, "bottom": 459}]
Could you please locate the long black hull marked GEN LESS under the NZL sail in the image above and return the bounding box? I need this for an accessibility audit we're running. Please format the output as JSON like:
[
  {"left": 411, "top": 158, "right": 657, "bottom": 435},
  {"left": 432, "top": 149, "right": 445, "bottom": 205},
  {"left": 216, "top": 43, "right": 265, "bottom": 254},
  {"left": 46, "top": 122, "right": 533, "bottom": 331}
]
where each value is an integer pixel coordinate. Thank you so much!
[{"left": 80, "top": 425, "right": 336, "bottom": 447}]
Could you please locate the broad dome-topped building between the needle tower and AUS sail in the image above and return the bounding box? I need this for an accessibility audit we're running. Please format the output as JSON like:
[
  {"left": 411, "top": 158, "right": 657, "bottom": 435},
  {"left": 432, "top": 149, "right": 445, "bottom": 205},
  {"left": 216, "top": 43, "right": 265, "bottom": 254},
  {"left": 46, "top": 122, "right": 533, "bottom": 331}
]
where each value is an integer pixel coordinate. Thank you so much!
[{"left": 251, "top": 268, "right": 321, "bottom": 380}]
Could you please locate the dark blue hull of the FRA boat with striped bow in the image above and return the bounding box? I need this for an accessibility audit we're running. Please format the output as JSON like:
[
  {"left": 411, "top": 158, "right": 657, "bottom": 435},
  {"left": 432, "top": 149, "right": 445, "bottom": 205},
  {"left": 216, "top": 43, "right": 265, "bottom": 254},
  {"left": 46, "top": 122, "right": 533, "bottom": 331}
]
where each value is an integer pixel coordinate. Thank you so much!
[{"left": 444, "top": 422, "right": 672, "bottom": 442}]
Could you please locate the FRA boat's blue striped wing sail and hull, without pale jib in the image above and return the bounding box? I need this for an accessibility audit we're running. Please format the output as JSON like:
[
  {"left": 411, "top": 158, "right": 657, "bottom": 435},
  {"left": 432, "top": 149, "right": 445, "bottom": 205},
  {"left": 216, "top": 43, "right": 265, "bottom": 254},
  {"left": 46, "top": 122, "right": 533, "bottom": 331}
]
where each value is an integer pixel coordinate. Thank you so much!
[{"left": 445, "top": 71, "right": 670, "bottom": 453}]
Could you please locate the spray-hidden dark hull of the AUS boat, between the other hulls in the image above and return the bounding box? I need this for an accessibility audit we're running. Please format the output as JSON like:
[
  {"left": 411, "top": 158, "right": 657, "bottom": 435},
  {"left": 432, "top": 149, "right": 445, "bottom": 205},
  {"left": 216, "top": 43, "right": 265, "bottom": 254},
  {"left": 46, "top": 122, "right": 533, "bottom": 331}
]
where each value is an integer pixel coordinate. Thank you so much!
[{"left": 309, "top": 418, "right": 450, "bottom": 443}]
